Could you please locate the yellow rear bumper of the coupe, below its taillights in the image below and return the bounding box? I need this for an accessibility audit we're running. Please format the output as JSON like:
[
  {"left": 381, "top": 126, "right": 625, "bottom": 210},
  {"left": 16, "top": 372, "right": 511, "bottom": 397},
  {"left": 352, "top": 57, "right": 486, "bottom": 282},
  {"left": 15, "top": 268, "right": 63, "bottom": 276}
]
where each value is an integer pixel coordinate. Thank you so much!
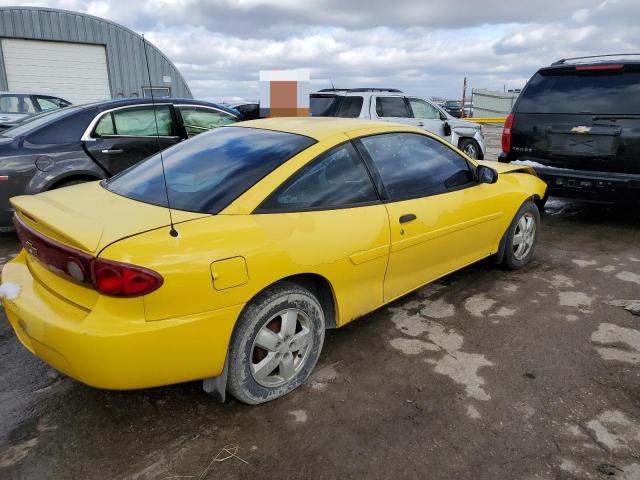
[{"left": 2, "top": 251, "right": 243, "bottom": 390}]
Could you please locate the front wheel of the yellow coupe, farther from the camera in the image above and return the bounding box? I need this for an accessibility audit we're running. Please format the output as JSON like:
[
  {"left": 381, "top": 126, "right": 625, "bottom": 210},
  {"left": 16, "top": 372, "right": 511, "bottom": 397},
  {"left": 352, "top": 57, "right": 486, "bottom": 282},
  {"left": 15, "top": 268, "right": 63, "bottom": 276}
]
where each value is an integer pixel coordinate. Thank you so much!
[{"left": 503, "top": 200, "right": 540, "bottom": 270}]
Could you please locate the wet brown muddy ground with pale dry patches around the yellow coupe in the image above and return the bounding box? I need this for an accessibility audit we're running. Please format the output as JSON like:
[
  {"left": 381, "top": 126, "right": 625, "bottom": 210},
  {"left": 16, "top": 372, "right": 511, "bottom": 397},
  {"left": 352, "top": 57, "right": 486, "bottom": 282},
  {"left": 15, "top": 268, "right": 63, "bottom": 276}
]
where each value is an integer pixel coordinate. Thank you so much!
[{"left": 0, "top": 126, "right": 640, "bottom": 480}]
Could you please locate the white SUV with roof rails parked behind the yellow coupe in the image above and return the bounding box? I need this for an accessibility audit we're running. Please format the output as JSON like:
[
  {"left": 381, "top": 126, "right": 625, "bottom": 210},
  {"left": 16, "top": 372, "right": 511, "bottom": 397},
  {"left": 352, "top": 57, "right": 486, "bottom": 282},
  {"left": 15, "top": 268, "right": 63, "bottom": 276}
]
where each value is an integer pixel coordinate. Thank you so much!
[{"left": 310, "top": 88, "right": 486, "bottom": 160}]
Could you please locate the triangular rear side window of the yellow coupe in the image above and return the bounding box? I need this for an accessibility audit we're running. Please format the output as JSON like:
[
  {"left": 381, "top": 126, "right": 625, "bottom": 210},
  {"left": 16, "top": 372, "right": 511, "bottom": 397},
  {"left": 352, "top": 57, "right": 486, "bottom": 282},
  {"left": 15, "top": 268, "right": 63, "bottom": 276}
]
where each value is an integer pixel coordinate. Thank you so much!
[{"left": 256, "top": 143, "right": 378, "bottom": 213}]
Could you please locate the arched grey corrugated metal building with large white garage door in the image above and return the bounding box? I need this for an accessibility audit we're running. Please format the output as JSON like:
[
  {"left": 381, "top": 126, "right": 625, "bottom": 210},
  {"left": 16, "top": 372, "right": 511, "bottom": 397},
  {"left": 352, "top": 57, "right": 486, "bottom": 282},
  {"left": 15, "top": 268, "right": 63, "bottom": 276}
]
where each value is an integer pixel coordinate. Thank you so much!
[{"left": 0, "top": 7, "right": 192, "bottom": 103}]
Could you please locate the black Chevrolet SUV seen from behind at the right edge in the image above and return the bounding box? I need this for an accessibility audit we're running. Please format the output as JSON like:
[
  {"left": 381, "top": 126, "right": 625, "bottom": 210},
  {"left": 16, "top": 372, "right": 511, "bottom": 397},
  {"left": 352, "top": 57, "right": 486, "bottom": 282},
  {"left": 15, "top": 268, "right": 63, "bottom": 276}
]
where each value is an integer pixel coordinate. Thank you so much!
[{"left": 499, "top": 55, "right": 640, "bottom": 202}]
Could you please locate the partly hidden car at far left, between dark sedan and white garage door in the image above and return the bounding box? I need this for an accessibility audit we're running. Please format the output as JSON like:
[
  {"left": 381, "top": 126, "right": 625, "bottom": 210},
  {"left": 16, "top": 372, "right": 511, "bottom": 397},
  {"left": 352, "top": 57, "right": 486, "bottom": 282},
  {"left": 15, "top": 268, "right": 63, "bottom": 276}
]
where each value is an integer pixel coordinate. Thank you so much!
[{"left": 0, "top": 92, "right": 71, "bottom": 131}]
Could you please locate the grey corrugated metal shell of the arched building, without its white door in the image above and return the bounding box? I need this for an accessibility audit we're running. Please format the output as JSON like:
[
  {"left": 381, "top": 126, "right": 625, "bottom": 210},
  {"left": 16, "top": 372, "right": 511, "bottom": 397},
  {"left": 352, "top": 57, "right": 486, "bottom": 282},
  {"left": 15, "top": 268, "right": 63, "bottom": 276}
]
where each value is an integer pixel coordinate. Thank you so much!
[{"left": 0, "top": 7, "right": 192, "bottom": 98}]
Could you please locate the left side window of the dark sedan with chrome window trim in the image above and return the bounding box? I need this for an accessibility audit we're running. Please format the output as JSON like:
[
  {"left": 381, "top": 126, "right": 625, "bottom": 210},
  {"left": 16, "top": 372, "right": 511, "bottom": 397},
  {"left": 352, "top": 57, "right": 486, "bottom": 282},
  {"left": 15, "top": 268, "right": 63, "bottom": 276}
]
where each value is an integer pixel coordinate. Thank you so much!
[{"left": 112, "top": 105, "right": 172, "bottom": 137}]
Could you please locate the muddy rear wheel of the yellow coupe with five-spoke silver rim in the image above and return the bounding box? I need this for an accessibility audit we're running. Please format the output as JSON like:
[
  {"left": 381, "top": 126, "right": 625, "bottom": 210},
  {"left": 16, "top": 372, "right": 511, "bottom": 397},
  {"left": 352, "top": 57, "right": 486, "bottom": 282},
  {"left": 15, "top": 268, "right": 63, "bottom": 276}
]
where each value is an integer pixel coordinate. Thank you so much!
[{"left": 227, "top": 282, "right": 325, "bottom": 405}]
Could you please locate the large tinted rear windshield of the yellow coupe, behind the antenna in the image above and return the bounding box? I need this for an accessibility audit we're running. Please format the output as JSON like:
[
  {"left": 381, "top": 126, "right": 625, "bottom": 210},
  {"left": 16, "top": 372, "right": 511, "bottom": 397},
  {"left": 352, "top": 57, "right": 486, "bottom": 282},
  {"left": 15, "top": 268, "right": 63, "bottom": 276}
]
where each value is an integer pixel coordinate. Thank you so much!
[{"left": 104, "top": 127, "right": 315, "bottom": 214}]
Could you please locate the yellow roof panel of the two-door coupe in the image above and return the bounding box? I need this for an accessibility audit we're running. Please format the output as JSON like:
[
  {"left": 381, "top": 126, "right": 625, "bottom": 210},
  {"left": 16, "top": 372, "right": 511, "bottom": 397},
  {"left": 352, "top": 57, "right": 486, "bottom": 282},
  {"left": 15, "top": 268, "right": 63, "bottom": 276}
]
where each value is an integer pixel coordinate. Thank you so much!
[{"left": 235, "top": 117, "right": 424, "bottom": 140}]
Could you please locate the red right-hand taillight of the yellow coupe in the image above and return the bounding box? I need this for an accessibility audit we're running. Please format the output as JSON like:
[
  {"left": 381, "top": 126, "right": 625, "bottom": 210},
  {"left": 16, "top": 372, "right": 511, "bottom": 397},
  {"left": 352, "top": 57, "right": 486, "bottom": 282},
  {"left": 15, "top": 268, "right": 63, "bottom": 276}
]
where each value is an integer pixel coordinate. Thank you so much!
[{"left": 91, "top": 258, "right": 163, "bottom": 297}]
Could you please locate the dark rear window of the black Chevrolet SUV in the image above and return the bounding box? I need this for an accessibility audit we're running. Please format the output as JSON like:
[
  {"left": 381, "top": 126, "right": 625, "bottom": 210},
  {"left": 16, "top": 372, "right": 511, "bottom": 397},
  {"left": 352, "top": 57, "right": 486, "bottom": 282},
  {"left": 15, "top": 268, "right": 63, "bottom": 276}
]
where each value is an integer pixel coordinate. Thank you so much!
[{"left": 516, "top": 68, "right": 640, "bottom": 115}]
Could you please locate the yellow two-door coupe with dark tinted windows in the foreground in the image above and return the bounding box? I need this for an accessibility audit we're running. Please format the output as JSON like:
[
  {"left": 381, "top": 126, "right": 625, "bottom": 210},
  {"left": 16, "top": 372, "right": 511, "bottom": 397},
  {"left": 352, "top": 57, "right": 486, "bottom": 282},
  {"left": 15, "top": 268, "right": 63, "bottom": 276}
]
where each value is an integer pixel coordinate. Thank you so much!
[{"left": 2, "top": 118, "right": 546, "bottom": 404}]
